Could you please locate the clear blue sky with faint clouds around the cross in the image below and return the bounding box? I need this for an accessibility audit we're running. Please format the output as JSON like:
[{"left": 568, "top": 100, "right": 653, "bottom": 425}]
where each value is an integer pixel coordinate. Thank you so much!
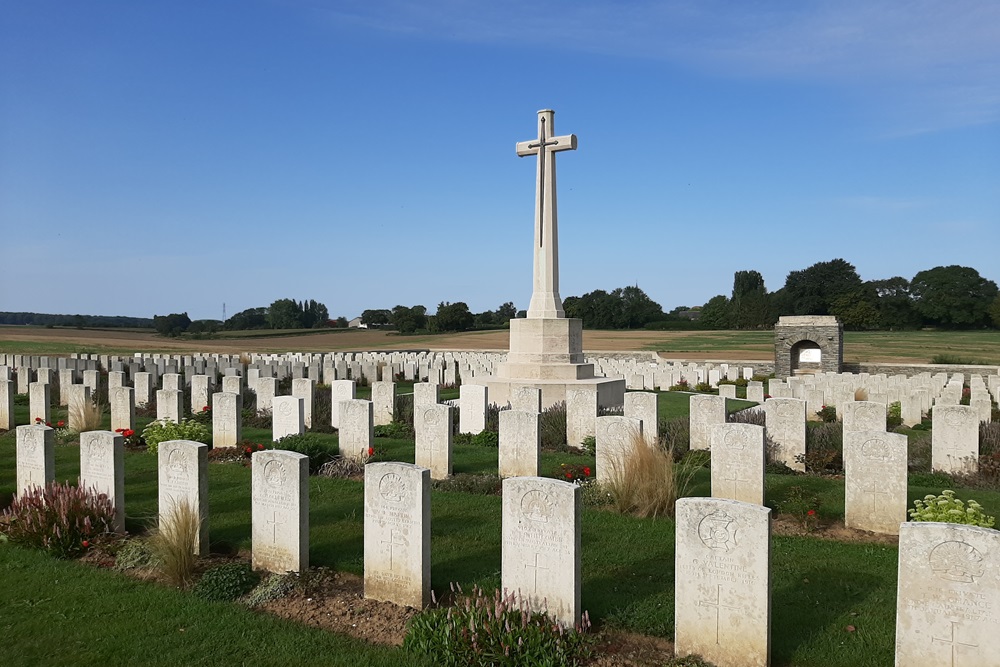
[{"left": 0, "top": 0, "right": 1000, "bottom": 319}]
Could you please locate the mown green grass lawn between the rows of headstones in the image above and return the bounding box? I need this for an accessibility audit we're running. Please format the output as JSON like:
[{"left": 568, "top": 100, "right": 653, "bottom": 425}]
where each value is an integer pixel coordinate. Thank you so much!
[{"left": 0, "top": 394, "right": 1000, "bottom": 667}]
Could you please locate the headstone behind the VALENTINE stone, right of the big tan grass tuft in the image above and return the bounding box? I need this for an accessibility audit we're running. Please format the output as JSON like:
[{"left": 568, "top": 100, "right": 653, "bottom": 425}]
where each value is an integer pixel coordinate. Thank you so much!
[{"left": 711, "top": 424, "right": 765, "bottom": 505}]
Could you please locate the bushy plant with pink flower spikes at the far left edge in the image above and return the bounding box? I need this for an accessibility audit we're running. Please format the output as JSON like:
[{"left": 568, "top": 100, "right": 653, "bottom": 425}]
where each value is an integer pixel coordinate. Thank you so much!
[{"left": 0, "top": 482, "right": 115, "bottom": 558}]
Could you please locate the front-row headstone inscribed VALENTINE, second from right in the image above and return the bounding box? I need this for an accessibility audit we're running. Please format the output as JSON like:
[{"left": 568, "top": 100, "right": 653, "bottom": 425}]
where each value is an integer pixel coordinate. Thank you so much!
[{"left": 674, "top": 498, "right": 771, "bottom": 667}]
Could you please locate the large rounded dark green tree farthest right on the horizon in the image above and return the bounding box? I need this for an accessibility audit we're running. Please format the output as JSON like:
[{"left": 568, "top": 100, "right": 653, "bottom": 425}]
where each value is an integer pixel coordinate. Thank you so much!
[{"left": 910, "top": 265, "right": 998, "bottom": 329}]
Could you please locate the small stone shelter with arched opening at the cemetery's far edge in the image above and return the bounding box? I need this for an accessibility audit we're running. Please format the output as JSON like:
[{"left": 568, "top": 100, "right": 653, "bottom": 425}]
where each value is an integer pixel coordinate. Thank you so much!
[{"left": 774, "top": 315, "right": 844, "bottom": 378}]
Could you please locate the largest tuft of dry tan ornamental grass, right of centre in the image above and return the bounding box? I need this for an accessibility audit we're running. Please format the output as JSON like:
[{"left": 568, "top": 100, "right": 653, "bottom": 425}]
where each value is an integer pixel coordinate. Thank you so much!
[{"left": 603, "top": 436, "right": 698, "bottom": 517}]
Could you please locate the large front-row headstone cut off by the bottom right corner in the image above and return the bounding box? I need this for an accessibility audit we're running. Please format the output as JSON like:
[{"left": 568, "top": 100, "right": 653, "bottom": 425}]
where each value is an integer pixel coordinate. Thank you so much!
[{"left": 896, "top": 524, "right": 1000, "bottom": 667}]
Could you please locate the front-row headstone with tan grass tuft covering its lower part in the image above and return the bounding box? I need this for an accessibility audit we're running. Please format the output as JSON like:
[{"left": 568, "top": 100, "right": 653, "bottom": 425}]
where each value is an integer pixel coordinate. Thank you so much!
[{"left": 156, "top": 440, "right": 208, "bottom": 555}]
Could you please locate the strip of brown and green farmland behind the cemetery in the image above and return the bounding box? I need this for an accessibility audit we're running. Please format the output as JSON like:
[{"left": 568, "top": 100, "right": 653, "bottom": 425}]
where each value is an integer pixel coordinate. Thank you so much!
[{"left": 0, "top": 326, "right": 1000, "bottom": 365}]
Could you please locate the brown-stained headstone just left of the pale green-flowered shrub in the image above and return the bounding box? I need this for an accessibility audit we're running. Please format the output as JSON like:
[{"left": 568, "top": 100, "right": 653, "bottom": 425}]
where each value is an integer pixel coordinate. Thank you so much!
[{"left": 844, "top": 429, "right": 907, "bottom": 535}]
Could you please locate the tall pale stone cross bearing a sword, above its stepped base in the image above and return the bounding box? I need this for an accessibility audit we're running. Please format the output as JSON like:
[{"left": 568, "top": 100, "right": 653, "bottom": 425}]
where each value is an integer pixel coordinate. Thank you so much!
[{"left": 517, "top": 109, "right": 576, "bottom": 318}]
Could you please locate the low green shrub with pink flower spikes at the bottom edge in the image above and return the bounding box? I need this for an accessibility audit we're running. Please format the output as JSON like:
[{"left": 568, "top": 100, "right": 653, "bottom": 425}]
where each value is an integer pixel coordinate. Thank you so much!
[{"left": 403, "top": 587, "right": 593, "bottom": 667}]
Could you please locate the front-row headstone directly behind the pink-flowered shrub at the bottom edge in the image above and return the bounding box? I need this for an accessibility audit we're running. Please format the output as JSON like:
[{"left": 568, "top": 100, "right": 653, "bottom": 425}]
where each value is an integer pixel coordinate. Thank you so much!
[{"left": 501, "top": 477, "right": 581, "bottom": 627}]
